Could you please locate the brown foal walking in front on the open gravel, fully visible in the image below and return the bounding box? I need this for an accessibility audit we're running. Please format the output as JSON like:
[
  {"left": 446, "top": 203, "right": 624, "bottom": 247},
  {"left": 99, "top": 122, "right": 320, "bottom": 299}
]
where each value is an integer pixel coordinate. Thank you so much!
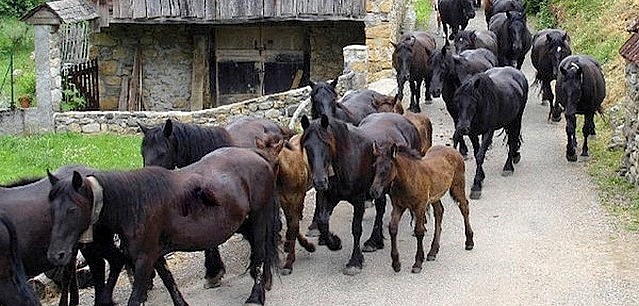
[{"left": 371, "top": 144, "right": 474, "bottom": 273}]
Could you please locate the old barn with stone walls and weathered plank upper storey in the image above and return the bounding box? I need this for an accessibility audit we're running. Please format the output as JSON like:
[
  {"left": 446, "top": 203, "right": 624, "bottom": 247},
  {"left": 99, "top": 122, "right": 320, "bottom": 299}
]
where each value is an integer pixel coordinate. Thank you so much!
[{"left": 23, "top": 0, "right": 406, "bottom": 111}]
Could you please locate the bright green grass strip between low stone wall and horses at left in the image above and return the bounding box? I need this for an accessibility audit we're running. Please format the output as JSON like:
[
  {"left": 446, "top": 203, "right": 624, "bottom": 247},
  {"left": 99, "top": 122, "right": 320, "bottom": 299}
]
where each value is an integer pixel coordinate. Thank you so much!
[{"left": 0, "top": 133, "right": 142, "bottom": 183}]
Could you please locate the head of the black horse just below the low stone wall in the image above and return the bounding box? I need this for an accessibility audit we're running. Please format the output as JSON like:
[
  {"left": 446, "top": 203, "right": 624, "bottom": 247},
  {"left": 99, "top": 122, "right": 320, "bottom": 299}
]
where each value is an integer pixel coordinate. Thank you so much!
[{"left": 138, "top": 119, "right": 177, "bottom": 169}]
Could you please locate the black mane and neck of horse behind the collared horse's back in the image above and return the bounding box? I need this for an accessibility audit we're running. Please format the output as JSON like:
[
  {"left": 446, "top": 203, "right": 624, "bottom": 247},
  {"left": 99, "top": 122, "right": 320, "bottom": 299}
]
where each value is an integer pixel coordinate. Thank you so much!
[{"left": 172, "top": 122, "right": 233, "bottom": 167}]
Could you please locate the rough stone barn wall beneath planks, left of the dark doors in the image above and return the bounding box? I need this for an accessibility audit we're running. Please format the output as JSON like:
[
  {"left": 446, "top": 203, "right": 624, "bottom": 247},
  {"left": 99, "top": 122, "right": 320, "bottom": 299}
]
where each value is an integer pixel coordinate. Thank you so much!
[{"left": 92, "top": 24, "right": 193, "bottom": 111}]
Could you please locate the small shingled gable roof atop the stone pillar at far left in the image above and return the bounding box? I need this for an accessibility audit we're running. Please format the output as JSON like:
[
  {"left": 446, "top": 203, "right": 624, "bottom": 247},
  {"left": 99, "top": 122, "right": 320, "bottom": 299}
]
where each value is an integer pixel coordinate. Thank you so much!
[{"left": 20, "top": 0, "right": 99, "bottom": 24}]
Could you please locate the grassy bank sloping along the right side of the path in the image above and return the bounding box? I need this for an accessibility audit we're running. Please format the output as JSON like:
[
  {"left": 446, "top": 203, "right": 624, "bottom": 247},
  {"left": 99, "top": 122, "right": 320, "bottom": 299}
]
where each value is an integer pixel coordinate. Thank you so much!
[{"left": 537, "top": 0, "right": 639, "bottom": 230}]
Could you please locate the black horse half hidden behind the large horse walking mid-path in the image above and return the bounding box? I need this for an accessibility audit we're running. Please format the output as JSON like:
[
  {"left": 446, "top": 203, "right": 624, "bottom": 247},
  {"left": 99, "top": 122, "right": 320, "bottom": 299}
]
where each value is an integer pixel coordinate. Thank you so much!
[{"left": 430, "top": 47, "right": 497, "bottom": 156}]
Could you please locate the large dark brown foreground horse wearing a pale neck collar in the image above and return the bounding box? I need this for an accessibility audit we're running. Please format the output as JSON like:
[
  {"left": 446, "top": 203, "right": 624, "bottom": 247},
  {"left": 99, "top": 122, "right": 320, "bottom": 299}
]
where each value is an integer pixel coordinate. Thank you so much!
[{"left": 47, "top": 148, "right": 281, "bottom": 305}]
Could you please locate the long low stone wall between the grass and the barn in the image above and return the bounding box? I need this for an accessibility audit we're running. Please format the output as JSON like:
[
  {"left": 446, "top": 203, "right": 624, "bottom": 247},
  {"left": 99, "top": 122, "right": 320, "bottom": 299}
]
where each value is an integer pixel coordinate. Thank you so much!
[{"left": 54, "top": 87, "right": 311, "bottom": 134}]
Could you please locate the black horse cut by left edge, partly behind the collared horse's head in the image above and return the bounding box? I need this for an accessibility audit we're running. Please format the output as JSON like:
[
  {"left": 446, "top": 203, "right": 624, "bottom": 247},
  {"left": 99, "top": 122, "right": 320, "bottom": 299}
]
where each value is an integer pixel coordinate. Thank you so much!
[{"left": 0, "top": 165, "right": 130, "bottom": 305}]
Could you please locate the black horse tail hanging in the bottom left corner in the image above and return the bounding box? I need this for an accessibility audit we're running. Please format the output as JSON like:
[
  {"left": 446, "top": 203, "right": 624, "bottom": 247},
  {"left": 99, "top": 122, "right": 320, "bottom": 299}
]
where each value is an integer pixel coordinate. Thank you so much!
[{"left": 0, "top": 212, "right": 40, "bottom": 305}]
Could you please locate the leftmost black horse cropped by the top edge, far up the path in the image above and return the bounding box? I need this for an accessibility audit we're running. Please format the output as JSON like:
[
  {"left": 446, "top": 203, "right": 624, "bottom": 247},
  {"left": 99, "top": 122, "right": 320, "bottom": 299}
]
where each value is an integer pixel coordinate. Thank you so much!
[{"left": 437, "top": 0, "right": 475, "bottom": 41}]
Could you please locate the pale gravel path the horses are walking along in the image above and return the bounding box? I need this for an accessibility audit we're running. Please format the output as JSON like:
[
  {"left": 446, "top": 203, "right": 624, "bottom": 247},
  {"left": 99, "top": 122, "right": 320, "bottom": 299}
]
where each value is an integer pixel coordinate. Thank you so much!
[{"left": 56, "top": 7, "right": 639, "bottom": 305}]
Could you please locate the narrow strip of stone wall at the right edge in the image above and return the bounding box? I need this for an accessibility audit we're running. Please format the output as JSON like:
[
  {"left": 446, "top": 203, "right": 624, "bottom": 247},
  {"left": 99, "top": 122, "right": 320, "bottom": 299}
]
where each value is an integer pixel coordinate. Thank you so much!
[{"left": 621, "top": 62, "right": 639, "bottom": 186}]
